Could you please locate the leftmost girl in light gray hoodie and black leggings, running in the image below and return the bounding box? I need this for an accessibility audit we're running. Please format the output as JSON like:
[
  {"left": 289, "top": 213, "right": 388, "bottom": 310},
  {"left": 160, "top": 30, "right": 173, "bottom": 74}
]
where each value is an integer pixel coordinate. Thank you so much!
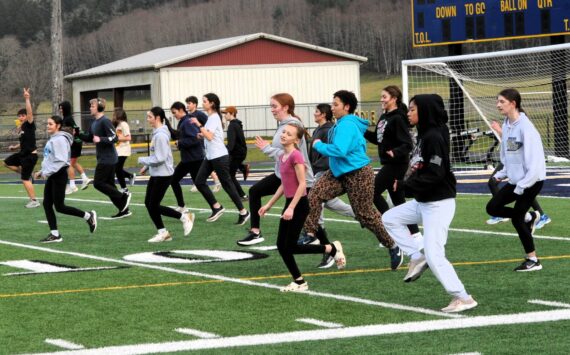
[{"left": 35, "top": 116, "right": 97, "bottom": 243}]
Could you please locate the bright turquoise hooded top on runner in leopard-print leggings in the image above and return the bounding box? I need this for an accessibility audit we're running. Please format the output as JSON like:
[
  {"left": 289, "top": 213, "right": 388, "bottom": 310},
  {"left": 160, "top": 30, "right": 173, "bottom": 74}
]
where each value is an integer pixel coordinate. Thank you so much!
[{"left": 313, "top": 114, "right": 370, "bottom": 178}]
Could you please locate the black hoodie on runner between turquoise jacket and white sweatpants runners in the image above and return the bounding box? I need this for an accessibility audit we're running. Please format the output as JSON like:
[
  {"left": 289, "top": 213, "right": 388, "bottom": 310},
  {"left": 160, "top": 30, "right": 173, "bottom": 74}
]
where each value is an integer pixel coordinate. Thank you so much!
[{"left": 364, "top": 108, "right": 413, "bottom": 165}]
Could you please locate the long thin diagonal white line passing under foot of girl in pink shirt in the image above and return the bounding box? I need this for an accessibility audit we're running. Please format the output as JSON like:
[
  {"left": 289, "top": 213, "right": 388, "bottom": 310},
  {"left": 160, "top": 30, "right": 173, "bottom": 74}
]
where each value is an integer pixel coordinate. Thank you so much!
[{"left": 0, "top": 240, "right": 463, "bottom": 318}]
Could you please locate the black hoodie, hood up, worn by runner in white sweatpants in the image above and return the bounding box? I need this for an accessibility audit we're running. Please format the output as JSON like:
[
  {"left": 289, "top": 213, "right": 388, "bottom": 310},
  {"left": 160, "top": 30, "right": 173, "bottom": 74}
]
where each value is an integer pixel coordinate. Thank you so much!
[{"left": 398, "top": 95, "right": 457, "bottom": 202}]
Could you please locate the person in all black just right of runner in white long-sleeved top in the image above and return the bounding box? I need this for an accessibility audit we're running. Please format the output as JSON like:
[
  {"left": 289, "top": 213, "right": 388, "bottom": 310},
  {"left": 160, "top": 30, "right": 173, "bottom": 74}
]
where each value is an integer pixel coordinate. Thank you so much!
[{"left": 222, "top": 106, "right": 249, "bottom": 201}]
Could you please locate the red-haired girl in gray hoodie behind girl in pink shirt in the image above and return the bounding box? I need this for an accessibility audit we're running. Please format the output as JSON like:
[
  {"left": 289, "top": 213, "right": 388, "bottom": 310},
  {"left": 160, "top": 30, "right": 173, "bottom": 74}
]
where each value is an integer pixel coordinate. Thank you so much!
[{"left": 237, "top": 93, "right": 314, "bottom": 246}]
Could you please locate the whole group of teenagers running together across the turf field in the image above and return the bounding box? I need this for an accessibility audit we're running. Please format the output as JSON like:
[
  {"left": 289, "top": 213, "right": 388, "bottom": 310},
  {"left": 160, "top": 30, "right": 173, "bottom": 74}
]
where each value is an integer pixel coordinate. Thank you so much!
[{"left": 6, "top": 86, "right": 546, "bottom": 312}]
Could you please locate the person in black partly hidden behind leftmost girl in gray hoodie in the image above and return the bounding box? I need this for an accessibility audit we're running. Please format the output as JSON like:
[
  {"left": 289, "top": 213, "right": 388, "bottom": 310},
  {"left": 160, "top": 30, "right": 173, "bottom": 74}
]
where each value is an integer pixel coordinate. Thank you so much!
[{"left": 59, "top": 101, "right": 93, "bottom": 195}]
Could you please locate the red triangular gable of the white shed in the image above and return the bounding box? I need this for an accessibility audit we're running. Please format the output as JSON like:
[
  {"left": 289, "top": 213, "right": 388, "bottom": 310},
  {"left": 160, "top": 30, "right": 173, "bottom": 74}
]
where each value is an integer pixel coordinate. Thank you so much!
[{"left": 168, "top": 38, "right": 347, "bottom": 68}]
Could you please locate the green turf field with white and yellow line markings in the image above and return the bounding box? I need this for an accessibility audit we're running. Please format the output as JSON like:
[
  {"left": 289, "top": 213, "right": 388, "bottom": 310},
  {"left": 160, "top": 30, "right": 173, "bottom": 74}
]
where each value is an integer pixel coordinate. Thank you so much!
[{"left": 0, "top": 184, "right": 570, "bottom": 354}]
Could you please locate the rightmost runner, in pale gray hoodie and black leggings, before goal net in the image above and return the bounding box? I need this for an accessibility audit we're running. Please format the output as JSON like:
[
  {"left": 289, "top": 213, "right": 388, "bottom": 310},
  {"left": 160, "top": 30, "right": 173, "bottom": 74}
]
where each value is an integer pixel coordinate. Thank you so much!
[{"left": 487, "top": 88, "right": 546, "bottom": 271}]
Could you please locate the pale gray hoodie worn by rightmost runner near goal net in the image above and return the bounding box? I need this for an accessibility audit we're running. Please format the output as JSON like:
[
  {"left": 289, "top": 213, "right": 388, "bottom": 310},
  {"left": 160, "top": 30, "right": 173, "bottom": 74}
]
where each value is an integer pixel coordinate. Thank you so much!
[{"left": 495, "top": 112, "right": 546, "bottom": 195}]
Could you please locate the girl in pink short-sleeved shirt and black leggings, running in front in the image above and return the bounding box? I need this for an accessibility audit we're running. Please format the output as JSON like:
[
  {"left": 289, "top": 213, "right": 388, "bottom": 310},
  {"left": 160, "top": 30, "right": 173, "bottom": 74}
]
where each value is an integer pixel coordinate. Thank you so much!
[{"left": 259, "top": 124, "right": 346, "bottom": 292}]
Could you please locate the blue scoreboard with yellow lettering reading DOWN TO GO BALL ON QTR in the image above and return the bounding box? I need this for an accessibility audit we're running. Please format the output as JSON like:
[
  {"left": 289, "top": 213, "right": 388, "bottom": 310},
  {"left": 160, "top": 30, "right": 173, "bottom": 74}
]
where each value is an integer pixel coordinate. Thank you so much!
[{"left": 411, "top": 0, "right": 570, "bottom": 47}]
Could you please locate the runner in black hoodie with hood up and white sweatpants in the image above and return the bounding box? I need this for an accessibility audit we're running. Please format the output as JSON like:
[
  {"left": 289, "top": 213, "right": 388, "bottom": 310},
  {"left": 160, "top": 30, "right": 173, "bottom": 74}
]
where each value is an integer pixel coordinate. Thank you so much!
[{"left": 382, "top": 95, "right": 477, "bottom": 313}]
